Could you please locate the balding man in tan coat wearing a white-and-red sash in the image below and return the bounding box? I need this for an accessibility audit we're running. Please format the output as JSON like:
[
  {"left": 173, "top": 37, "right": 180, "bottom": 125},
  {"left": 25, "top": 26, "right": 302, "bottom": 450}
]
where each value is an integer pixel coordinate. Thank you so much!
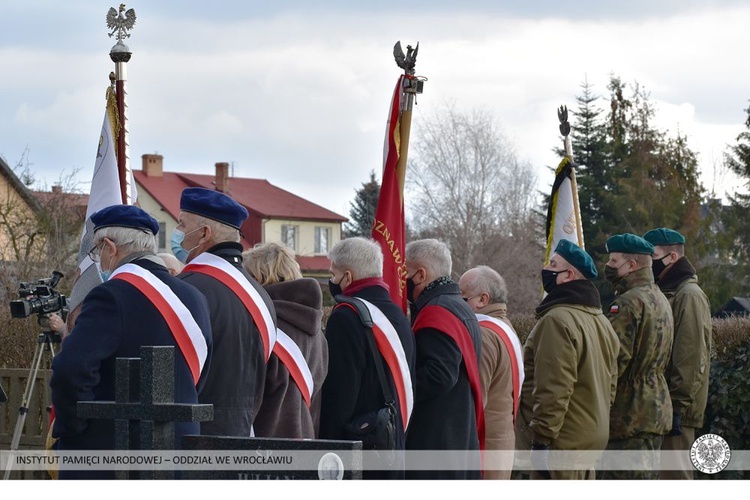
[{"left": 458, "top": 266, "right": 523, "bottom": 479}]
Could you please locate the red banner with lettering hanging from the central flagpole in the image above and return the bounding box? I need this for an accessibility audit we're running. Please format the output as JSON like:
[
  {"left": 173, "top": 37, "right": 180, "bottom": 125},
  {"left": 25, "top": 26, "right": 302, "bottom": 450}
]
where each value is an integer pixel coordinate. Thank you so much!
[{"left": 372, "top": 75, "right": 407, "bottom": 312}]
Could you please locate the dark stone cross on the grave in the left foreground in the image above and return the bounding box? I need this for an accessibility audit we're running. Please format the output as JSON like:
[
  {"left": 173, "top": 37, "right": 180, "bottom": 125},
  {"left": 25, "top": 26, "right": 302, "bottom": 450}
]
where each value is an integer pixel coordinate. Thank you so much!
[{"left": 77, "top": 346, "right": 214, "bottom": 479}]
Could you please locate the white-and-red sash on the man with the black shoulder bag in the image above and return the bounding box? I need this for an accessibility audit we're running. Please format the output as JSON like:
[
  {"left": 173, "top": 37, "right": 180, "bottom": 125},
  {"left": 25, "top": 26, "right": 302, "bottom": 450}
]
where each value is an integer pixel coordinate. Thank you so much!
[{"left": 339, "top": 297, "right": 414, "bottom": 430}]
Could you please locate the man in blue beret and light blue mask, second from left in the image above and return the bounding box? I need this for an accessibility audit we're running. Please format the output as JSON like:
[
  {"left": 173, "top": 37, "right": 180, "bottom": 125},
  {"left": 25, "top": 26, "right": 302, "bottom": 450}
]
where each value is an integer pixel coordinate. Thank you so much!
[{"left": 172, "top": 188, "right": 276, "bottom": 437}]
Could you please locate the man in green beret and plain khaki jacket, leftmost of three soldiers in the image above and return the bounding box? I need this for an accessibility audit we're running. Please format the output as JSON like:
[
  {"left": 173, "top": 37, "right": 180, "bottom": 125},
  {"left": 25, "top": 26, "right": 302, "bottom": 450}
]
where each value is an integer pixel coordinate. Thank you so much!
[{"left": 516, "top": 240, "right": 619, "bottom": 479}]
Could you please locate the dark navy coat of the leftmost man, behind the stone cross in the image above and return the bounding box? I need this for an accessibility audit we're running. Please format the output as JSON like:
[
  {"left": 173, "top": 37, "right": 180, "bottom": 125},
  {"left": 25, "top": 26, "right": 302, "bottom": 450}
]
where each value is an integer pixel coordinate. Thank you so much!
[{"left": 50, "top": 259, "right": 212, "bottom": 478}]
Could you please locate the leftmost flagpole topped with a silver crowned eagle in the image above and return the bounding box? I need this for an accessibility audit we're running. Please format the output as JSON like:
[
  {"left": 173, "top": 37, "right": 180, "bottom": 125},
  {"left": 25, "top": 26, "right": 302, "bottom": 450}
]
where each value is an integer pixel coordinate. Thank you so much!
[{"left": 107, "top": 3, "right": 135, "bottom": 204}]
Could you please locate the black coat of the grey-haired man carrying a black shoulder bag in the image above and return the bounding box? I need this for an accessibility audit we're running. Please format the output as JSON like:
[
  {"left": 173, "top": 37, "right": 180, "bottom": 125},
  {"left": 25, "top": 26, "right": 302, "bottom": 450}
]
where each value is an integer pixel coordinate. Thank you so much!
[{"left": 320, "top": 285, "right": 414, "bottom": 479}]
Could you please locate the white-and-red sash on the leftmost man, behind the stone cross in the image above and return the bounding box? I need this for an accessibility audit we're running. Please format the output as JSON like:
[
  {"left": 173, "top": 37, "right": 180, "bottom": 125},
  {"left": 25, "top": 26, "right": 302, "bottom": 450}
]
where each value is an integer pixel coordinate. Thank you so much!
[{"left": 110, "top": 264, "right": 208, "bottom": 384}]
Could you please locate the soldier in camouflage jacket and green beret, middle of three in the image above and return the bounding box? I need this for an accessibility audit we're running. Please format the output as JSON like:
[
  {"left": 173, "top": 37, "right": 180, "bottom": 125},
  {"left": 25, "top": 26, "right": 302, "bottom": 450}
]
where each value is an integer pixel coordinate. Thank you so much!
[{"left": 602, "top": 233, "right": 674, "bottom": 479}]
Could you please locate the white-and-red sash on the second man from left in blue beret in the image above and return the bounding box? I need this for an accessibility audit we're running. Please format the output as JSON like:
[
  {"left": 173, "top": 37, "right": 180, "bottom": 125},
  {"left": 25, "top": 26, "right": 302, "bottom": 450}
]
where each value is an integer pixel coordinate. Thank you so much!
[{"left": 182, "top": 252, "right": 276, "bottom": 362}]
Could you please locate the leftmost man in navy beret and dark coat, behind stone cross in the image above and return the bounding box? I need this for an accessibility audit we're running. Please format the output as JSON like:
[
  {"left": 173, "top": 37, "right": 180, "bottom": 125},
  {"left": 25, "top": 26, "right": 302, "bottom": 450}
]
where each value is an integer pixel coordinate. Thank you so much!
[{"left": 50, "top": 205, "right": 212, "bottom": 479}]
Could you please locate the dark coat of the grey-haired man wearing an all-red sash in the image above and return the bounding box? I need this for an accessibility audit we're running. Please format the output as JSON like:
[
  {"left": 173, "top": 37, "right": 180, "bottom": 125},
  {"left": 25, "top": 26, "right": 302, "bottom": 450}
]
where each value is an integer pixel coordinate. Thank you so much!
[{"left": 406, "top": 283, "right": 481, "bottom": 479}]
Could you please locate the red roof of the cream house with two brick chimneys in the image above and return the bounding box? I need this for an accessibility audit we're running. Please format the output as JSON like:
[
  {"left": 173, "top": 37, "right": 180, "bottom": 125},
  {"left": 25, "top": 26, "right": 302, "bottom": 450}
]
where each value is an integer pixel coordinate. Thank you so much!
[{"left": 133, "top": 170, "right": 348, "bottom": 222}]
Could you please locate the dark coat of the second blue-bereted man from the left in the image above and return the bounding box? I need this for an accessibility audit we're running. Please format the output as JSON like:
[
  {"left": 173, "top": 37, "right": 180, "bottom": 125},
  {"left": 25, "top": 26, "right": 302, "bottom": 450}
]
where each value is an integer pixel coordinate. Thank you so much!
[{"left": 178, "top": 242, "right": 276, "bottom": 437}]
